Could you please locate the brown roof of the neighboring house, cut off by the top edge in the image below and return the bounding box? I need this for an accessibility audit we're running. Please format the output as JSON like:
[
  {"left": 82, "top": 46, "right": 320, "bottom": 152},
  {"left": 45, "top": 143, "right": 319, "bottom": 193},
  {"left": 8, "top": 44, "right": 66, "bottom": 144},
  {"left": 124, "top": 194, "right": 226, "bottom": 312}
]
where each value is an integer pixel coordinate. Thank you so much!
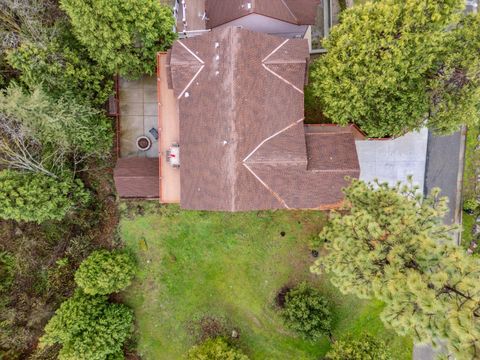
[{"left": 205, "top": 0, "right": 320, "bottom": 28}]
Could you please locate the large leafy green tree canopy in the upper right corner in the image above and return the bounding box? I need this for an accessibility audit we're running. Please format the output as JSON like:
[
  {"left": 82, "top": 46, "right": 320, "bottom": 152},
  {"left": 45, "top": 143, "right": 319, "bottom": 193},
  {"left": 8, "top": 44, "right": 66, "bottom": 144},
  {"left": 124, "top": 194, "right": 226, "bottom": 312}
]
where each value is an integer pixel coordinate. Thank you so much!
[{"left": 311, "top": 0, "right": 480, "bottom": 137}]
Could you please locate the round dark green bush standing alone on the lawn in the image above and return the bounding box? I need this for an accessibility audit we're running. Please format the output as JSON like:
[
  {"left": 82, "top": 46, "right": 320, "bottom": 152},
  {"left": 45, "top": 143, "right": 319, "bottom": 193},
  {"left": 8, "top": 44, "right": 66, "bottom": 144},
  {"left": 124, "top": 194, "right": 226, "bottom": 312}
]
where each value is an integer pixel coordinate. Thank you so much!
[{"left": 281, "top": 282, "right": 332, "bottom": 340}]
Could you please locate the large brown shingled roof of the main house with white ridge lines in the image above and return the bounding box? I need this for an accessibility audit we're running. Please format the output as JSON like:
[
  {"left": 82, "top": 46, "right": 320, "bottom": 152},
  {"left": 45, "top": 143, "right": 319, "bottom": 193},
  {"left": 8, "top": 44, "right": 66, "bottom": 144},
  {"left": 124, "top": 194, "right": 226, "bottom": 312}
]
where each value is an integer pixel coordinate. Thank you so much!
[{"left": 170, "top": 27, "right": 359, "bottom": 211}]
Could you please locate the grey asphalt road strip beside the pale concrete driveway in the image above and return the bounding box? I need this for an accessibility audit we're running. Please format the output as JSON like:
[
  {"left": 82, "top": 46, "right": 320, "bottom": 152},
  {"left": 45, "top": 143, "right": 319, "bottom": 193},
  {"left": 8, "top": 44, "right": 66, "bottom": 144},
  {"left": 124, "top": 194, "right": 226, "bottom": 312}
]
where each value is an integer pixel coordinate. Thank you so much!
[{"left": 425, "top": 131, "right": 465, "bottom": 224}]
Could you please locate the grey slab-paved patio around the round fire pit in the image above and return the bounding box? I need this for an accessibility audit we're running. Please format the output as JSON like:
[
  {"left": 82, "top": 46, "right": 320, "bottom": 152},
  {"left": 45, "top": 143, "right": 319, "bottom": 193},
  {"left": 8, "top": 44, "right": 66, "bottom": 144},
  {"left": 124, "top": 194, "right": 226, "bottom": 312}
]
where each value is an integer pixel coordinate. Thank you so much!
[{"left": 119, "top": 76, "right": 158, "bottom": 158}]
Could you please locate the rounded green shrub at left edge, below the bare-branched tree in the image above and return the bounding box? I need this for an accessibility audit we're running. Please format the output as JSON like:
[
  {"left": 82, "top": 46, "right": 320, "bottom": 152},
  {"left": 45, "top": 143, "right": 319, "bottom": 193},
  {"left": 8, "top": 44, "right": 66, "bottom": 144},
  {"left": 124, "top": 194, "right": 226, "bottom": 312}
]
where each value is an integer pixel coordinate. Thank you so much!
[{"left": 0, "top": 170, "right": 89, "bottom": 223}]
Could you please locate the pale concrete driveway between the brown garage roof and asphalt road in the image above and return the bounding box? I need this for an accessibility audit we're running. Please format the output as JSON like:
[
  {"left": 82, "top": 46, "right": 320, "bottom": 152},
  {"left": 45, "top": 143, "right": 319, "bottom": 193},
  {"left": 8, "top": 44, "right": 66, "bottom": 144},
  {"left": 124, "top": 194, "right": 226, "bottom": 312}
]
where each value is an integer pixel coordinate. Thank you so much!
[{"left": 355, "top": 129, "right": 428, "bottom": 191}]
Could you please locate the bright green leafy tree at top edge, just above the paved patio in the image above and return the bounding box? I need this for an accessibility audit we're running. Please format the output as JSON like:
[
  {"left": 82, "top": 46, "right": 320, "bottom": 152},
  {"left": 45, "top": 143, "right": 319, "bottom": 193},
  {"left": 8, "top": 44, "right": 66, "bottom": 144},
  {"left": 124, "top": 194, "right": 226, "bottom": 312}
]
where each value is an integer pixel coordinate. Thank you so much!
[{"left": 60, "top": 0, "right": 175, "bottom": 77}]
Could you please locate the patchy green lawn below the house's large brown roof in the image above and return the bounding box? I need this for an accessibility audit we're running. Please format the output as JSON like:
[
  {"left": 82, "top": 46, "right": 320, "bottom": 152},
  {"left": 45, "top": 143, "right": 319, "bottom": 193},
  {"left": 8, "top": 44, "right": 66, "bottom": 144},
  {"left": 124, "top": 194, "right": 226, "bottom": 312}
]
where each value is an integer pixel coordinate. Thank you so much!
[{"left": 120, "top": 203, "right": 412, "bottom": 360}]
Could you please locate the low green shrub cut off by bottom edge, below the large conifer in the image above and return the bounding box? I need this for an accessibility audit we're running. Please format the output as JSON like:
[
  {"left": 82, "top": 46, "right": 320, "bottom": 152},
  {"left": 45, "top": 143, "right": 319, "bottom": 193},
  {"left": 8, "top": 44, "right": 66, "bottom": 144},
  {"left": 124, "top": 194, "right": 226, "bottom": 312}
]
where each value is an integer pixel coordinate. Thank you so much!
[{"left": 325, "top": 335, "right": 391, "bottom": 360}]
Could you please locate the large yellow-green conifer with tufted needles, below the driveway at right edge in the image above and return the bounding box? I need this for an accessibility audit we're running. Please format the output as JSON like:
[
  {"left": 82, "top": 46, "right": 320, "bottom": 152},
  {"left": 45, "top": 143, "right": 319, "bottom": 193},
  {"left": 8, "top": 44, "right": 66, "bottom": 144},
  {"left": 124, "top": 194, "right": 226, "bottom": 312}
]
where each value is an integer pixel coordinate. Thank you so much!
[{"left": 312, "top": 179, "right": 480, "bottom": 359}]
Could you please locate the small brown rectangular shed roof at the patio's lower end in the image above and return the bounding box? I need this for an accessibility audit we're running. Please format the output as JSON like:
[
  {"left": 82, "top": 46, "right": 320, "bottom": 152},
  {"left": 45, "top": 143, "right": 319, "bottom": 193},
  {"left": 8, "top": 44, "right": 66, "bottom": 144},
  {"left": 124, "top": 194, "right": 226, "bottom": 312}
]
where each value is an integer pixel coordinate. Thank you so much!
[{"left": 113, "top": 158, "right": 160, "bottom": 199}]
